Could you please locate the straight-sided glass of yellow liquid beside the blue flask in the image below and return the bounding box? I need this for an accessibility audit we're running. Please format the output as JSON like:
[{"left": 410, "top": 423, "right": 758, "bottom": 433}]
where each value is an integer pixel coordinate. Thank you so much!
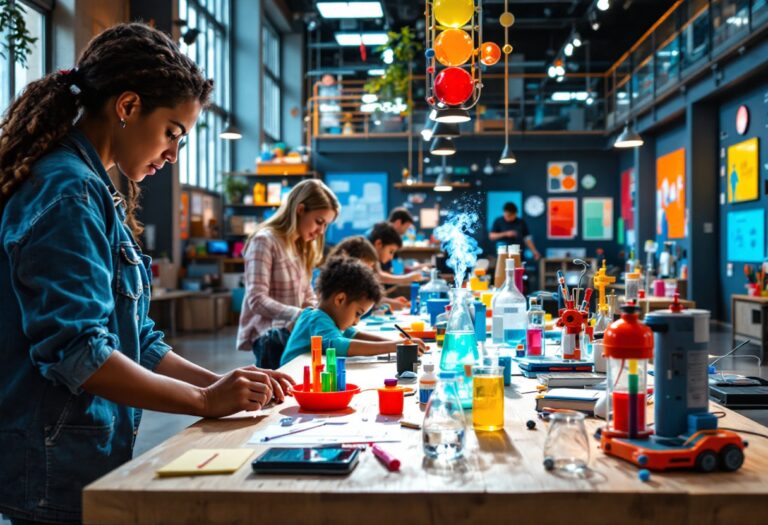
[{"left": 472, "top": 366, "right": 504, "bottom": 431}]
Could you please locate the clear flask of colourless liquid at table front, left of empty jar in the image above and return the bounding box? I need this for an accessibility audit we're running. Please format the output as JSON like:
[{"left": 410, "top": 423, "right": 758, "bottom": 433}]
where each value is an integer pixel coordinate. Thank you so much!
[{"left": 421, "top": 371, "right": 467, "bottom": 461}]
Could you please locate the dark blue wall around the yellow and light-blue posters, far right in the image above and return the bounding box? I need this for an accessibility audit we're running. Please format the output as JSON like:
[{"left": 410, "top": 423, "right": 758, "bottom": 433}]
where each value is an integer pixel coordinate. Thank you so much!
[{"left": 718, "top": 81, "right": 768, "bottom": 319}]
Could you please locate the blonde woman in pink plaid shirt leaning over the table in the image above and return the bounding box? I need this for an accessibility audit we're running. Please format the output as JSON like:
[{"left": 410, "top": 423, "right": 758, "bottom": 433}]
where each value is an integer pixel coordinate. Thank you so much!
[{"left": 237, "top": 179, "right": 340, "bottom": 368}]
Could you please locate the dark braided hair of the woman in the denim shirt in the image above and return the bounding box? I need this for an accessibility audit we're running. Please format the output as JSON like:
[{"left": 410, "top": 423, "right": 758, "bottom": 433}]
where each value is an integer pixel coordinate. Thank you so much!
[{"left": 0, "top": 23, "right": 213, "bottom": 237}]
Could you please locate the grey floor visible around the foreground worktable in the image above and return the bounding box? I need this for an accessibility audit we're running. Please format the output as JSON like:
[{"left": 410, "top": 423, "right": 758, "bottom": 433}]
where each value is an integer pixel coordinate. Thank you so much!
[{"left": 0, "top": 323, "right": 768, "bottom": 525}]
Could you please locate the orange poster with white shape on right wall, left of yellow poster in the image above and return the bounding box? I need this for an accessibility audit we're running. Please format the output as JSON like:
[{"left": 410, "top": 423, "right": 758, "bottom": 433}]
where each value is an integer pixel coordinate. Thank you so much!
[{"left": 656, "top": 148, "right": 688, "bottom": 242}]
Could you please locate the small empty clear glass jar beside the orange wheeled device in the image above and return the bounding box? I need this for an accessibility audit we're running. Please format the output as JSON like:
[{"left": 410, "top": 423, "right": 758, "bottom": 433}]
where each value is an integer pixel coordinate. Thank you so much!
[{"left": 544, "top": 410, "right": 590, "bottom": 477}]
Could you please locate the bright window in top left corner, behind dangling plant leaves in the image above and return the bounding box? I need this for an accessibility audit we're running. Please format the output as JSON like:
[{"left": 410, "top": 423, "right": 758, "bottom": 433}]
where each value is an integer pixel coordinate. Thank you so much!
[{"left": 0, "top": 0, "right": 48, "bottom": 112}]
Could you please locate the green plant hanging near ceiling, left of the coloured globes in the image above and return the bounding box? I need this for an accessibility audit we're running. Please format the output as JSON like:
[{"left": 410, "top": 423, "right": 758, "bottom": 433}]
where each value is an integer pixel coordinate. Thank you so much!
[{"left": 365, "top": 26, "right": 423, "bottom": 113}]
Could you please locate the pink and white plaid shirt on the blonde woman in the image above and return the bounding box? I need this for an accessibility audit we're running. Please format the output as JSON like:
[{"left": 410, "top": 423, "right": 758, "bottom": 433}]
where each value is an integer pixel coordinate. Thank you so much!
[{"left": 237, "top": 230, "right": 317, "bottom": 351}]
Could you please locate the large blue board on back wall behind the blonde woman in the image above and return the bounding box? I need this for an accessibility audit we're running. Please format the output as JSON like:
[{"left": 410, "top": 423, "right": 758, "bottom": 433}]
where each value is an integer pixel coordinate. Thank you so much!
[{"left": 325, "top": 172, "right": 388, "bottom": 244}]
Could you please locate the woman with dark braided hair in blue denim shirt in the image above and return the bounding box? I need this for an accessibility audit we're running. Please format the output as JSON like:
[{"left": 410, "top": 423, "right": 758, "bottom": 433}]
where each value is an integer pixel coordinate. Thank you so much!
[{"left": 0, "top": 24, "right": 292, "bottom": 524}]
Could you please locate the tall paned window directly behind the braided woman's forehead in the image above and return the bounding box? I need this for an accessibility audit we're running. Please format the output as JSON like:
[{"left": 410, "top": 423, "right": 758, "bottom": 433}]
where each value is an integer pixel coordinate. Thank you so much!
[{"left": 179, "top": 0, "right": 231, "bottom": 191}]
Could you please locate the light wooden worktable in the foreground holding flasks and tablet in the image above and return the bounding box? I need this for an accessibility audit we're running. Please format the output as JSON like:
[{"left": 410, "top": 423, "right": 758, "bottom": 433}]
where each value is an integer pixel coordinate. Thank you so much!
[{"left": 83, "top": 344, "right": 768, "bottom": 525}]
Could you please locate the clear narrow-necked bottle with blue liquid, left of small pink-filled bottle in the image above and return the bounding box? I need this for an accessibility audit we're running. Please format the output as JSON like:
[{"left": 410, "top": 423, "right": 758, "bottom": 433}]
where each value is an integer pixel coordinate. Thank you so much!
[{"left": 491, "top": 259, "right": 528, "bottom": 348}]
